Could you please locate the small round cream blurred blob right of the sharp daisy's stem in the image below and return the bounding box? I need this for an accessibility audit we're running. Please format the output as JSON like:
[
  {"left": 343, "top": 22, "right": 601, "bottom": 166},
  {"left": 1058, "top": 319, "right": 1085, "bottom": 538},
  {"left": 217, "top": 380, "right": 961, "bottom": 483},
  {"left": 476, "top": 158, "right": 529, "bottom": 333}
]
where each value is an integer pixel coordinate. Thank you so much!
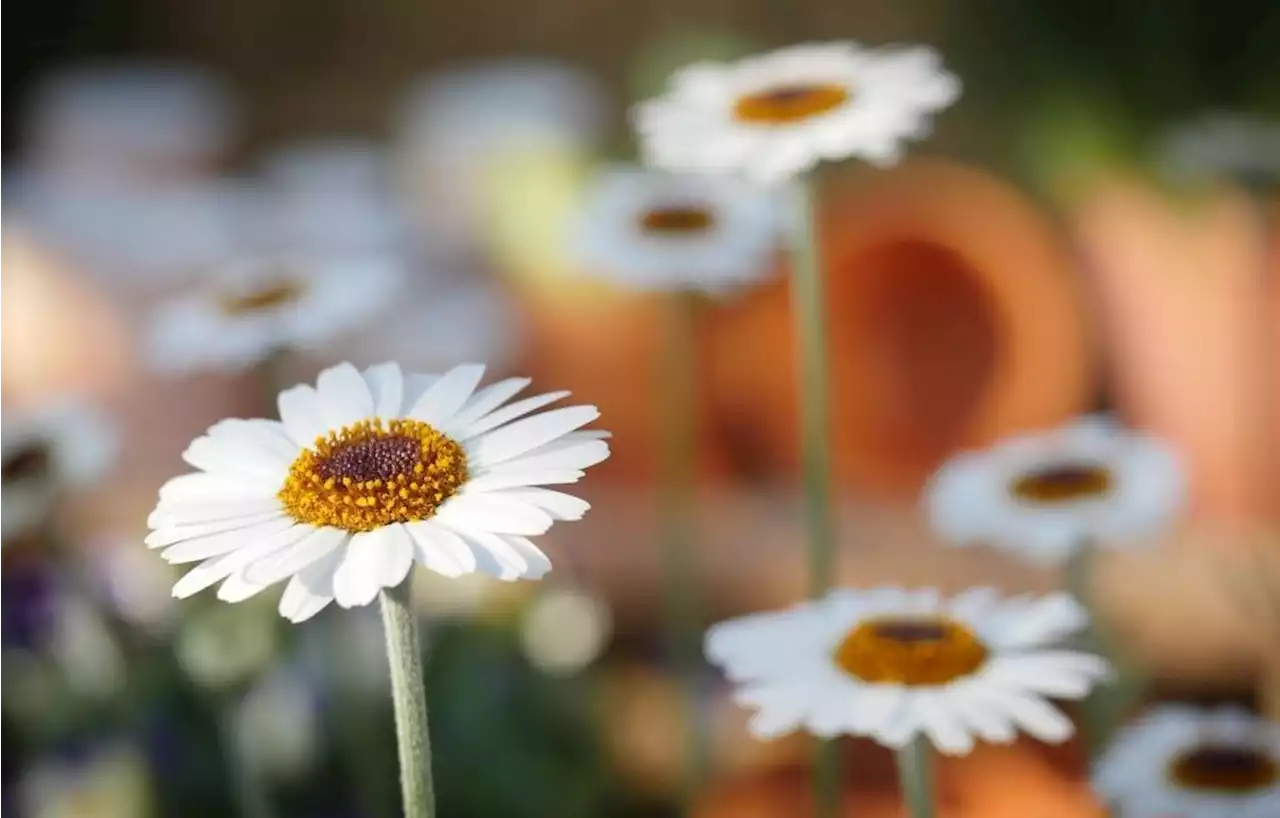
[{"left": 521, "top": 588, "right": 613, "bottom": 676}]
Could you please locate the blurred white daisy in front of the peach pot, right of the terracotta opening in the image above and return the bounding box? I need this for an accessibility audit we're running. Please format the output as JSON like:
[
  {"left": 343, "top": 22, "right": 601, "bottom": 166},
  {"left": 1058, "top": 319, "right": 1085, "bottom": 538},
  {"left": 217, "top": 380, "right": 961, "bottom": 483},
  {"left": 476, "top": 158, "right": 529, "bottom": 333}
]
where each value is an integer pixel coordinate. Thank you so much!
[{"left": 924, "top": 417, "right": 1187, "bottom": 563}]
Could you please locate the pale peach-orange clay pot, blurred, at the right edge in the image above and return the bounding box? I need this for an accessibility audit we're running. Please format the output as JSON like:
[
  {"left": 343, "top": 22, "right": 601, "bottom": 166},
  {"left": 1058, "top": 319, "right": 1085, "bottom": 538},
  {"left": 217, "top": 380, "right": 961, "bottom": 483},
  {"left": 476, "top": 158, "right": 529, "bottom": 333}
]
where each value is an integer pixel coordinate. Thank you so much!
[{"left": 1073, "top": 179, "right": 1280, "bottom": 521}]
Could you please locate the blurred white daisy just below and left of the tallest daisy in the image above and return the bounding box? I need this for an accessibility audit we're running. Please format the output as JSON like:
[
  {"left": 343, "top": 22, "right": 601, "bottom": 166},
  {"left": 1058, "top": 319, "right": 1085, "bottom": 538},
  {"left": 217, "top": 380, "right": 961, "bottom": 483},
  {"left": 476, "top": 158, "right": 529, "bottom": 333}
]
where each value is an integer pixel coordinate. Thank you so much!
[{"left": 573, "top": 165, "right": 781, "bottom": 292}]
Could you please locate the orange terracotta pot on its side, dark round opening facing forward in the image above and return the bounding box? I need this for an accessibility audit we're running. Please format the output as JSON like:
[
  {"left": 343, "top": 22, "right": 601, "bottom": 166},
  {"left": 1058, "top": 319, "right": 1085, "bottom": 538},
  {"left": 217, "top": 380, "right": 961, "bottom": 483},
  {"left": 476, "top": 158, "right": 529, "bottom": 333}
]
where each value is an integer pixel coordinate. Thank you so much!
[{"left": 710, "top": 160, "right": 1094, "bottom": 494}]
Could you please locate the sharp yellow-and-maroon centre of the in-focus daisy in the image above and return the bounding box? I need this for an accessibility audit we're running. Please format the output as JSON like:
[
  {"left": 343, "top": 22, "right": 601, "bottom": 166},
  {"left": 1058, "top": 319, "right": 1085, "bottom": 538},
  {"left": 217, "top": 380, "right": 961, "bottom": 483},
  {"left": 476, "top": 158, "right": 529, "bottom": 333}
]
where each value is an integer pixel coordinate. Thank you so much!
[{"left": 279, "top": 420, "right": 467, "bottom": 531}]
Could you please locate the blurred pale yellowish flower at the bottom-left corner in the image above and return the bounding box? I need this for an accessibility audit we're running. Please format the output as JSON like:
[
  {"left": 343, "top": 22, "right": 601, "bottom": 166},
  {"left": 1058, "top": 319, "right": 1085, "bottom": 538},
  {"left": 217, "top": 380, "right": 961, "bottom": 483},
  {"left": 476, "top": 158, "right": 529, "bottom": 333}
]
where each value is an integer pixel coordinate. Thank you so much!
[{"left": 18, "top": 741, "right": 154, "bottom": 818}]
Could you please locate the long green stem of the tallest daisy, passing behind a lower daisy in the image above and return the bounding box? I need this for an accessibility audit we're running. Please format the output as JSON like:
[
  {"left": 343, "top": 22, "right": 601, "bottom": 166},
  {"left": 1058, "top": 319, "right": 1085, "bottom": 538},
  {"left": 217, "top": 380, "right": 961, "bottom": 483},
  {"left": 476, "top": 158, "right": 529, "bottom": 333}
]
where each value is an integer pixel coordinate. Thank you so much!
[{"left": 790, "top": 176, "right": 841, "bottom": 818}]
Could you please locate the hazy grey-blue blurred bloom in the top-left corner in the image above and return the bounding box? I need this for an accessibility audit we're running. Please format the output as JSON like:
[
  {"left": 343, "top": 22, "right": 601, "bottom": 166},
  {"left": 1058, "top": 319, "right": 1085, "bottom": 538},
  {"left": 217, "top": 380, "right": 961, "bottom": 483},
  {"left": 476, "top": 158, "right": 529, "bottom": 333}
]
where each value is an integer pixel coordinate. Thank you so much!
[{"left": 23, "top": 63, "right": 239, "bottom": 183}]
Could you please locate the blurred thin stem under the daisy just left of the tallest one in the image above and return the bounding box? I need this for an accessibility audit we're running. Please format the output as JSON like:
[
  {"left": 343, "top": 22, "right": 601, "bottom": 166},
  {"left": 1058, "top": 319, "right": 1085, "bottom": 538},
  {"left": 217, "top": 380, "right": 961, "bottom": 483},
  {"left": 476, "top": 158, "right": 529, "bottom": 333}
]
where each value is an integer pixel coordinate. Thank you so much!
[{"left": 658, "top": 292, "right": 710, "bottom": 809}]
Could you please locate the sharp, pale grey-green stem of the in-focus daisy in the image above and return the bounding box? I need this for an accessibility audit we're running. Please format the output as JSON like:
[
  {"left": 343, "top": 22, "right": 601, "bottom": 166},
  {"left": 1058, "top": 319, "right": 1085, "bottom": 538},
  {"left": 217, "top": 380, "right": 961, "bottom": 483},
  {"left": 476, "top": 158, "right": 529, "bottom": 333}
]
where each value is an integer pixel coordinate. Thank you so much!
[{"left": 381, "top": 580, "right": 435, "bottom": 818}]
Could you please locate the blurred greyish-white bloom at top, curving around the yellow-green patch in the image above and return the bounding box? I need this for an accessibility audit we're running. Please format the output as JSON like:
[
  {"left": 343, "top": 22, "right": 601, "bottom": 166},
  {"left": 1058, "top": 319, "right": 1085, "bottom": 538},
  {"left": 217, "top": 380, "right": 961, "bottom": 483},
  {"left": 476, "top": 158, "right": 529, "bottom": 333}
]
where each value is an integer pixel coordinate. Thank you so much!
[{"left": 396, "top": 59, "right": 609, "bottom": 251}]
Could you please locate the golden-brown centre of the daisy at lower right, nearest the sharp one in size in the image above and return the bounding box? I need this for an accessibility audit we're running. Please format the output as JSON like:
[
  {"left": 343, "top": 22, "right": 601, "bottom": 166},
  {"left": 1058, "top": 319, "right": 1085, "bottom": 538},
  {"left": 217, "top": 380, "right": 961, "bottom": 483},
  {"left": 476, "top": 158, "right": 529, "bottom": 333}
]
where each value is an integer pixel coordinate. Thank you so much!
[{"left": 835, "top": 617, "right": 987, "bottom": 686}]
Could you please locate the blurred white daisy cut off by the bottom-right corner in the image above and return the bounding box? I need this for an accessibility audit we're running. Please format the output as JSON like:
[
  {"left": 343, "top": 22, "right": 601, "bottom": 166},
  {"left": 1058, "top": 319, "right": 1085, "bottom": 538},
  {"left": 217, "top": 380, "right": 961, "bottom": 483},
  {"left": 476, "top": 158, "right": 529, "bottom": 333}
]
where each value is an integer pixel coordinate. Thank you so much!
[{"left": 1093, "top": 705, "right": 1280, "bottom": 818}]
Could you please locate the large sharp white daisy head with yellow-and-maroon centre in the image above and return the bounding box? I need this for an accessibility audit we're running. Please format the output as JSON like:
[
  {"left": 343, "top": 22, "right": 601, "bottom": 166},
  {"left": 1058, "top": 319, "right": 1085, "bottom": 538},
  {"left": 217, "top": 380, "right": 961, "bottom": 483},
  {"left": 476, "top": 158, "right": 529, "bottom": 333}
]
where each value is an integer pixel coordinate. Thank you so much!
[{"left": 146, "top": 364, "right": 609, "bottom": 622}]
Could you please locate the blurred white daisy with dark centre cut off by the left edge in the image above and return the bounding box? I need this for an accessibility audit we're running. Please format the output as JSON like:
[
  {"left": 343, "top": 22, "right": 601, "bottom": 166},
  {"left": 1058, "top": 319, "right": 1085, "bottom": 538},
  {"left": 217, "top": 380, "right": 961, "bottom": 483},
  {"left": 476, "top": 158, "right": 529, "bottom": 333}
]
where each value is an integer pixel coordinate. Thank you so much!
[{"left": 0, "top": 399, "right": 118, "bottom": 545}]
